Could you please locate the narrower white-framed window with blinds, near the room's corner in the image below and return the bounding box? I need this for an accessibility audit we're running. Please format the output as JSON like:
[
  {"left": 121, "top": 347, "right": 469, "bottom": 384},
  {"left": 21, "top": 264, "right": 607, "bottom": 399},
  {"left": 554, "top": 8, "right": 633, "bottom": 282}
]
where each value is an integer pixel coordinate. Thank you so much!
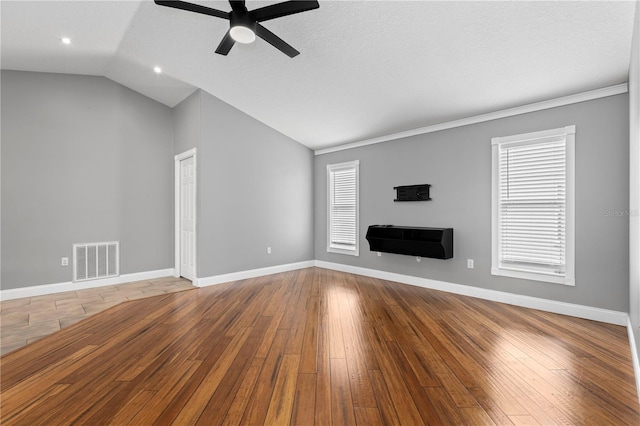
[{"left": 327, "top": 161, "right": 359, "bottom": 256}]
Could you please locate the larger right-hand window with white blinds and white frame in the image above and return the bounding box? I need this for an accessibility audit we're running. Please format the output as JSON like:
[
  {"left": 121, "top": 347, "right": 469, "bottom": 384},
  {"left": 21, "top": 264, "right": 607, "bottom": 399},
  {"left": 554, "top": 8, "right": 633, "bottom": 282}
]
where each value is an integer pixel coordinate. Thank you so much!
[{"left": 491, "top": 126, "right": 575, "bottom": 285}]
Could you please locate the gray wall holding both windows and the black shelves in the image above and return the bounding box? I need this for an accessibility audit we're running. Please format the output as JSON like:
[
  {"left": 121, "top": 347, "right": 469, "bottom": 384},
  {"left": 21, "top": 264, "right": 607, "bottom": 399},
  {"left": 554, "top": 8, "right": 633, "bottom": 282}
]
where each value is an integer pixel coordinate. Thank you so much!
[{"left": 315, "top": 94, "right": 629, "bottom": 312}]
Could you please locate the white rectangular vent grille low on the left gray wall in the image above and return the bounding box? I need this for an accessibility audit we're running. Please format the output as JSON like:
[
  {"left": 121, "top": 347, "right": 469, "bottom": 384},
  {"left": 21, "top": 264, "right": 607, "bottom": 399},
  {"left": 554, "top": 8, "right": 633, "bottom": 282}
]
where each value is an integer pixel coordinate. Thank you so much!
[{"left": 73, "top": 241, "right": 120, "bottom": 281}]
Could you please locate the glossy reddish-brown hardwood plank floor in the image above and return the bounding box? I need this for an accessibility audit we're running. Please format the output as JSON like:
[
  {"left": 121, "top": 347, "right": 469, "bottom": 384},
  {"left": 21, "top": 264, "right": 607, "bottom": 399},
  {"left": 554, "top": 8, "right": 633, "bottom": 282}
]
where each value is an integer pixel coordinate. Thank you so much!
[{"left": 0, "top": 268, "right": 640, "bottom": 425}]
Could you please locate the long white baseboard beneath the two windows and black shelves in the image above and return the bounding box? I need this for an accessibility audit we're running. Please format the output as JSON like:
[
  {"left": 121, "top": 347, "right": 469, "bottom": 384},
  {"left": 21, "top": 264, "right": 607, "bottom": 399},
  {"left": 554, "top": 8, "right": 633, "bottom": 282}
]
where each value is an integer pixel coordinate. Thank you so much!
[{"left": 315, "top": 260, "right": 628, "bottom": 326}]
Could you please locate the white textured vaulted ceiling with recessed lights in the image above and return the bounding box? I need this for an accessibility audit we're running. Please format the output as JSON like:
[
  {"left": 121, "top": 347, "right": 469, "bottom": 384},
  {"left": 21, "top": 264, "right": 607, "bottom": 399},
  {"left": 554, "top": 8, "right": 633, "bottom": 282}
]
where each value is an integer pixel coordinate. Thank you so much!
[{"left": 0, "top": 0, "right": 635, "bottom": 149}]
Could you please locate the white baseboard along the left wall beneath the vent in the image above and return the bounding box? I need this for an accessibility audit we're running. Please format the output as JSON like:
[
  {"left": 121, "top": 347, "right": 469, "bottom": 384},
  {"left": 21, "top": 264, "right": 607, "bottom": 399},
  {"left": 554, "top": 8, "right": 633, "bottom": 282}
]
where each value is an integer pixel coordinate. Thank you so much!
[{"left": 0, "top": 268, "right": 175, "bottom": 300}]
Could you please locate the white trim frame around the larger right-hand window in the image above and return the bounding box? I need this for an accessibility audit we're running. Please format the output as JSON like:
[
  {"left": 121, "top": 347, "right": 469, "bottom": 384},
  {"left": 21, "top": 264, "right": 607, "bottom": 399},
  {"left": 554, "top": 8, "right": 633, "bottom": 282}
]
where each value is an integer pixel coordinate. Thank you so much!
[{"left": 491, "top": 126, "right": 576, "bottom": 286}]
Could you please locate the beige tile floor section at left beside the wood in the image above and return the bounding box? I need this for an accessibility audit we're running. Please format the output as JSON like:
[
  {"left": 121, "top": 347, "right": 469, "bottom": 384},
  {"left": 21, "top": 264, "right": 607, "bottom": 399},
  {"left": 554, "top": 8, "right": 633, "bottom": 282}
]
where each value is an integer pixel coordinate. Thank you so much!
[{"left": 0, "top": 277, "right": 195, "bottom": 355}]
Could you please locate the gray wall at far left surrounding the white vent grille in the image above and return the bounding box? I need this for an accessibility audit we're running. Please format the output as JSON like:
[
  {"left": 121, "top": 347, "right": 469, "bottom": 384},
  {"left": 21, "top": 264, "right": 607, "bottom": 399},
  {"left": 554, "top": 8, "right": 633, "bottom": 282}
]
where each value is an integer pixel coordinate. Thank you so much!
[{"left": 1, "top": 71, "right": 173, "bottom": 289}]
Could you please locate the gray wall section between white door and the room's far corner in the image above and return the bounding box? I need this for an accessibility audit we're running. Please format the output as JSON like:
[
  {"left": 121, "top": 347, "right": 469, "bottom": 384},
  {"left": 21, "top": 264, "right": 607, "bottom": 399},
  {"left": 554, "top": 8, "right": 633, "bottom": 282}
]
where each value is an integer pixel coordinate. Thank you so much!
[{"left": 174, "top": 90, "right": 314, "bottom": 278}]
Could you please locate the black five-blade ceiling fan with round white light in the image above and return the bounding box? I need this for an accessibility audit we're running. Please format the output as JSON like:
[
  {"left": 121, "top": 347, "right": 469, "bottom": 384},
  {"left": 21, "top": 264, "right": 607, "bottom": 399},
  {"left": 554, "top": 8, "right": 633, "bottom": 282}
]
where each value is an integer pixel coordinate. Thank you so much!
[{"left": 155, "top": 0, "right": 320, "bottom": 58}]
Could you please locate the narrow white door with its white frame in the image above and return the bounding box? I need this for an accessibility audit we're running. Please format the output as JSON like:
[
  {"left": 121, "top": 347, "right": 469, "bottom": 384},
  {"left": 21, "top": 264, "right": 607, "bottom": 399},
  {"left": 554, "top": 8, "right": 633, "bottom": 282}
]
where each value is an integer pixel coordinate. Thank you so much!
[{"left": 175, "top": 148, "right": 197, "bottom": 285}]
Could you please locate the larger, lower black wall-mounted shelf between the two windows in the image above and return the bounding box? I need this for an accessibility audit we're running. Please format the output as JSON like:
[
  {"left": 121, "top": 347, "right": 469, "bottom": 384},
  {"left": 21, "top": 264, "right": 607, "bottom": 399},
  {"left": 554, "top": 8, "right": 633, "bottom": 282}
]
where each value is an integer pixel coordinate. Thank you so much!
[{"left": 367, "top": 225, "right": 453, "bottom": 259}]
